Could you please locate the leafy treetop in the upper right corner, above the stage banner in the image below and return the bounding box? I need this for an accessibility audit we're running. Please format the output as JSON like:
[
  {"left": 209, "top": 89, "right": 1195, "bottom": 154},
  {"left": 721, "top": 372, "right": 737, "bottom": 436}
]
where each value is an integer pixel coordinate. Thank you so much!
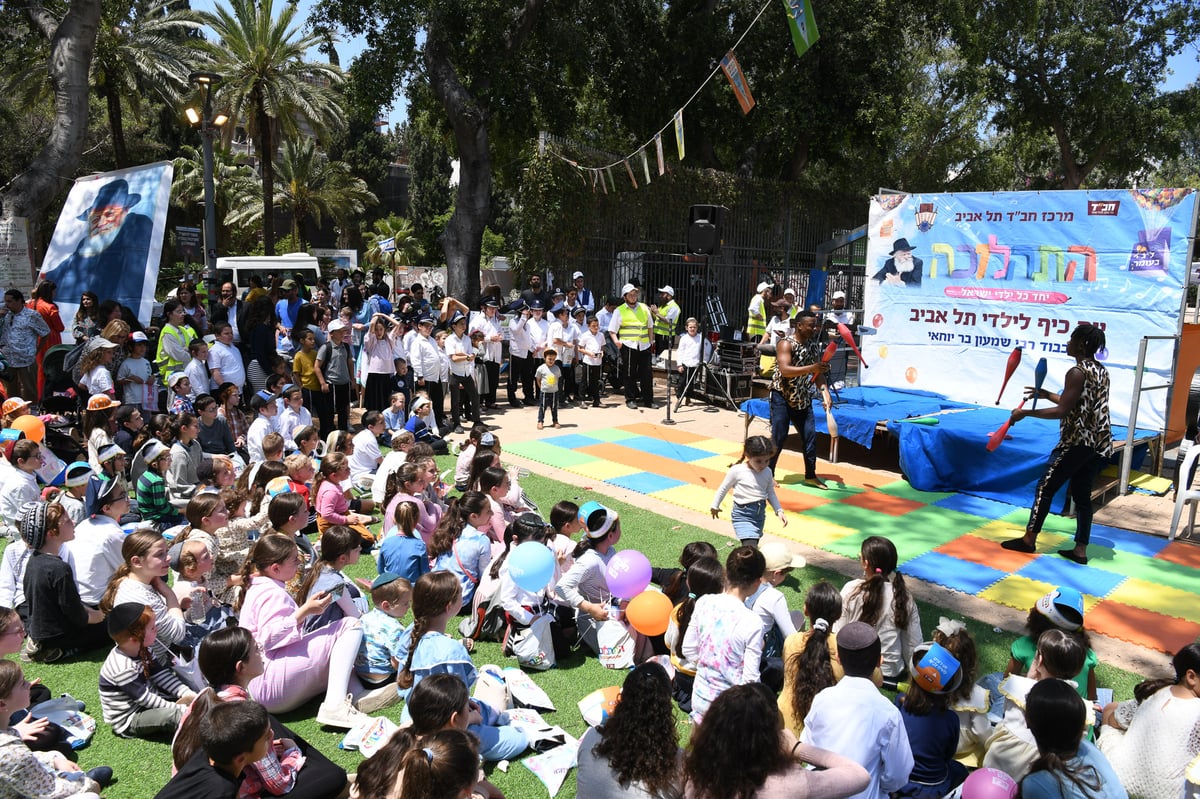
[{"left": 952, "top": 0, "right": 1200, "bottom": 188}]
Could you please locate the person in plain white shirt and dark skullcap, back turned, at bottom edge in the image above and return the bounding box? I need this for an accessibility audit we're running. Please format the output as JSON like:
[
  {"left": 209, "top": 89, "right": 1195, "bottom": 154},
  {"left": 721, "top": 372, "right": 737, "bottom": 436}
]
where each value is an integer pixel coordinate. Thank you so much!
[{"left": 800, "top": 619, "right": 913, "bottom": 799}]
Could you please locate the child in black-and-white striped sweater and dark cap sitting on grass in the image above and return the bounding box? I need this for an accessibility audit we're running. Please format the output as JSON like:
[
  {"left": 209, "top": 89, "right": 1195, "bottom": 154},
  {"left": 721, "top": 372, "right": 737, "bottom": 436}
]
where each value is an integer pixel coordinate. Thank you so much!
[{"left": 100, "top": 602, "right": 196, "bottom": 738}]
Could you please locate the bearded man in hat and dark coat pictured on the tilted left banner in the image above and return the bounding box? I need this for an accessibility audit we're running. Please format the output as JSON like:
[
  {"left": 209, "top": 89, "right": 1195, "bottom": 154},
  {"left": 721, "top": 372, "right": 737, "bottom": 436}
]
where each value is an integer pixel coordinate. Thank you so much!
[{"left": 40, "top": 179, "right": 154, "bottom": 308}]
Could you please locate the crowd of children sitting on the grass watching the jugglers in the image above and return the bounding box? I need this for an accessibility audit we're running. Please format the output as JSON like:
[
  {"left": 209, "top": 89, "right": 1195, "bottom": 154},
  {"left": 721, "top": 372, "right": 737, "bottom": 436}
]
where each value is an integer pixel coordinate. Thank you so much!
[{"left": 0, "top": 333, "right": 1200, "bottom": 799}]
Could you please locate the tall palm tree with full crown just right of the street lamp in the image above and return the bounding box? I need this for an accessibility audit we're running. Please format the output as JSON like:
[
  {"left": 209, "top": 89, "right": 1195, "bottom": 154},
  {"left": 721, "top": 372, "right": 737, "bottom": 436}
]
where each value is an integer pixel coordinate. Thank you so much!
[{"left": 202, "top": 0, "right": 343, "bottom": 256}]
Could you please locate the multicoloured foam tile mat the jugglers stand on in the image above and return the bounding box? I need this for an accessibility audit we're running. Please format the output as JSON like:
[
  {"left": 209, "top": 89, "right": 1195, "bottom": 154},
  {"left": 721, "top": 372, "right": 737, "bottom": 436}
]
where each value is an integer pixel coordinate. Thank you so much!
[{"left": 506, "top": 423, "right": 1200, "bottom": 653}]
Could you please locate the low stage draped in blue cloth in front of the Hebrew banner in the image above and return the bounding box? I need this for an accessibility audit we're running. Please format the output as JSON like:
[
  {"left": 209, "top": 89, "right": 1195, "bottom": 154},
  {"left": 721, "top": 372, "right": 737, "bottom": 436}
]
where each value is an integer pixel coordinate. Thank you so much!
[{"left": 742, "top": 388, "right": 1160, "bottom": 509}]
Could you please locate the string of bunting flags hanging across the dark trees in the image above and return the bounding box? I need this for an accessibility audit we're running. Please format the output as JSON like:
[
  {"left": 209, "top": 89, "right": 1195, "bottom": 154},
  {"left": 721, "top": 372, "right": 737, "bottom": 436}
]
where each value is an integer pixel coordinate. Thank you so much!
[{"left": 537, "top": 0, "right": 817, "bottom": 194}]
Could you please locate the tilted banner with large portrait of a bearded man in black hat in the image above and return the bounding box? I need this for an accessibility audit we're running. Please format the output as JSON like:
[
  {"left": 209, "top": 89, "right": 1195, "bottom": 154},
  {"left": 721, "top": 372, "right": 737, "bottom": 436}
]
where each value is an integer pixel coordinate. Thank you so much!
[{"left": 38, "top": 161, "right": 173, "bottom": 341}]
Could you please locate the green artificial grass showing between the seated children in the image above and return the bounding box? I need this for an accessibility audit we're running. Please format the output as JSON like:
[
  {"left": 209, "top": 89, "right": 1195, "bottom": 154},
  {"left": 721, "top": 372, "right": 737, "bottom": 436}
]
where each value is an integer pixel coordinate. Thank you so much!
[{"left": 12, "top": 467, "right": 1141, "bottom": 799}]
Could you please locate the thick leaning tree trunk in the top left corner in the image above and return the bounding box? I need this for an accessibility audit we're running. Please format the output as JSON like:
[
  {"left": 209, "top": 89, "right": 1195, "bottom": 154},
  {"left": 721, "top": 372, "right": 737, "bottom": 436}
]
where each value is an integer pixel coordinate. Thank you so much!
[{"left": 0, "top": 0, "right": 100, "bottom": 220}]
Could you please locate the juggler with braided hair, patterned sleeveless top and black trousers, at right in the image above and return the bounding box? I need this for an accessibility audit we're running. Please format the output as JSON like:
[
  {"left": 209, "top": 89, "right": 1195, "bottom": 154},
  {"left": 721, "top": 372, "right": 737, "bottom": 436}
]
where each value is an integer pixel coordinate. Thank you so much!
[{"left": 1000, "top": 323, "right": 1112, "bottom": 564}]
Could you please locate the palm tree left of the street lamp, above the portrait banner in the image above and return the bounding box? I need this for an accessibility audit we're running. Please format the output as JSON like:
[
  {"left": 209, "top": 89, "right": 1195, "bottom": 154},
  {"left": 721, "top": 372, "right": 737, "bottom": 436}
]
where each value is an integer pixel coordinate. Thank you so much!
[{"left": 91, "top": 0, "right": 203, "bottom": 168}]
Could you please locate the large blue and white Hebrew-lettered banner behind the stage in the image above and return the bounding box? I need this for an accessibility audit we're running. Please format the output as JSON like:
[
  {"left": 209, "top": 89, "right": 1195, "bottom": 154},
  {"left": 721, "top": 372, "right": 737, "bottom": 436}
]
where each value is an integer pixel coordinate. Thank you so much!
[{"left": 862, "top": 188, "right": 1196, "bottom": 428}]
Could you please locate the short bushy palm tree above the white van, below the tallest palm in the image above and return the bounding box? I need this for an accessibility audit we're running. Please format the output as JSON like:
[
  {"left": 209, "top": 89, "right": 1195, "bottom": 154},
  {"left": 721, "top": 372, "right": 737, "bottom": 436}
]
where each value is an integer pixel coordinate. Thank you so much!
[{"left": 226, "top": 137, "right": 379, "bottom": 250}]
